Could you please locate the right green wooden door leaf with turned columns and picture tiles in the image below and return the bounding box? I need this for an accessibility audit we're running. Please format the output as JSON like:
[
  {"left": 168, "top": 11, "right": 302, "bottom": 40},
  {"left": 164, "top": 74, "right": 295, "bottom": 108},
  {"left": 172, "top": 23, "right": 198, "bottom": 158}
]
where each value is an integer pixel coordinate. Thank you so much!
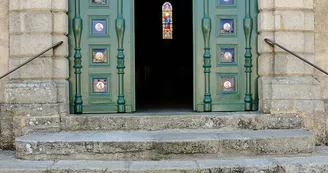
[{"left": 193, "top": 0, "right": 258, "bottom": 111}]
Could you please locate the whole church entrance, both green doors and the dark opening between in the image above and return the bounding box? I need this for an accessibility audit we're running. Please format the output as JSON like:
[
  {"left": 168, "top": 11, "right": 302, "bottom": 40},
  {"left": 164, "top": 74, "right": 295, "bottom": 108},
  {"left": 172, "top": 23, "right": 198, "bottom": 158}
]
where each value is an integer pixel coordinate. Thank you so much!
[{"left": 68, "top": 0, "right": 258, "bottom": 114}]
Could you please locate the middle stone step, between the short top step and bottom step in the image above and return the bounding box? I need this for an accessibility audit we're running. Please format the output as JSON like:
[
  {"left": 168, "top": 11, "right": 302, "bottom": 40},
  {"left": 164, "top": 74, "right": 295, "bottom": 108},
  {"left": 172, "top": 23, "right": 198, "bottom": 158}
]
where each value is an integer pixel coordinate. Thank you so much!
[{"left": 16, "top": 129, "right": 315, "bottom": 160}]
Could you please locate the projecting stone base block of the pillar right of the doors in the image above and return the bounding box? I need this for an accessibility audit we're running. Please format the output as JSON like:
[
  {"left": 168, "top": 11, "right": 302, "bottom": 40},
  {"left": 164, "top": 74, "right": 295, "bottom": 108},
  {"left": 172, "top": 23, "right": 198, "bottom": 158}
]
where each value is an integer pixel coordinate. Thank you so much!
[{"left": 259, "top": 76, "right": 325, "bottom": 114}]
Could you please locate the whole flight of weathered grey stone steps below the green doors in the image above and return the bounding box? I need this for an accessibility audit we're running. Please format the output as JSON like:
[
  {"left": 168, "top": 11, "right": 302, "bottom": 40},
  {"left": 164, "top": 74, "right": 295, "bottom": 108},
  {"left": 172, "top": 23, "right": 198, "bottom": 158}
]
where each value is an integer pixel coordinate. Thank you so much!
[{"left": 0, "top": 112, "right": 328, "bottom": 173}]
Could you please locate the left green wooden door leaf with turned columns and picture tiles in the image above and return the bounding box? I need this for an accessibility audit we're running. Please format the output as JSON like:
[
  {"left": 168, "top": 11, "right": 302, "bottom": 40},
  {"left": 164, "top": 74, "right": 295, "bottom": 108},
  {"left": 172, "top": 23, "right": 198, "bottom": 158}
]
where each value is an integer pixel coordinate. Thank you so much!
[{"left": 69, "top": 0, "right": 135, "bottom": 114}]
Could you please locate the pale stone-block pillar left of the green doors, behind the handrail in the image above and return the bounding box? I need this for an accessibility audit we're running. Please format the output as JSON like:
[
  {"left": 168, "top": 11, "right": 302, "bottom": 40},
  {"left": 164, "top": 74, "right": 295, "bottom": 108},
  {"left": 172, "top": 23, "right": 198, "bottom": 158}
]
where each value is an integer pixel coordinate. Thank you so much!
[{"left": 1, "top": 0, "right": 68, "bottom": 148}]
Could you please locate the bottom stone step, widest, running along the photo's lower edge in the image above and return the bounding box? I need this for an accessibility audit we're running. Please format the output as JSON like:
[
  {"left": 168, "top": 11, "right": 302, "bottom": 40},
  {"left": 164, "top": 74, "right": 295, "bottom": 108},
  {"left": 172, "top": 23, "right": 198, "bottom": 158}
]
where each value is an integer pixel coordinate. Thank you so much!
[{"left": 0, "top": 147, "right": 328, "bottom": 173}]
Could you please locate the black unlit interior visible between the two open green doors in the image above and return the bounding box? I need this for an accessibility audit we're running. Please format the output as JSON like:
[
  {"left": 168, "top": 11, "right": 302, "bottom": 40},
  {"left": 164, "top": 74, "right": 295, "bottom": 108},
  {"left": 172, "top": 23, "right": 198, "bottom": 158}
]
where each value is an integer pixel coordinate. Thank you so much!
[{"left": 135, "top": 0, "right": 193, "bottom": 111}]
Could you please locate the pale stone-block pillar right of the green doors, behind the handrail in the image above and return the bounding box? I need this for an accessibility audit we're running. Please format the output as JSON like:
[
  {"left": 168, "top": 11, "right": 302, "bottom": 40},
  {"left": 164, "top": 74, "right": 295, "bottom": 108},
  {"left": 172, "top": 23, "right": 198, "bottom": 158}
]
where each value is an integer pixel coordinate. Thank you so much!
[{"left": 258, "top": 0, "right": 326, "bottom": 143}]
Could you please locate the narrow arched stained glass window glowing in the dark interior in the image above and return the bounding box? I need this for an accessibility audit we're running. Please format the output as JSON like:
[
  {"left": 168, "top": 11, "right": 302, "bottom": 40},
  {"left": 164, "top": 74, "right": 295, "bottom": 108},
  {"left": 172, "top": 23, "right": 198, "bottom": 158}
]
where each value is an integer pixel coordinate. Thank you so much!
[{"left": 162, "top": 2, "right": 173, "bottom": 39}]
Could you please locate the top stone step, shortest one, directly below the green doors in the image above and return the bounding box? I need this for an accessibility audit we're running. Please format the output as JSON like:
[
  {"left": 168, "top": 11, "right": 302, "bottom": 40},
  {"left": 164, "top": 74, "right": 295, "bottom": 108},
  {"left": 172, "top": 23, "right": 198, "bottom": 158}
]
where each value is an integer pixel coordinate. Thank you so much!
[{"left": 61, "top": 112, "right": 303, "bottom": 131}]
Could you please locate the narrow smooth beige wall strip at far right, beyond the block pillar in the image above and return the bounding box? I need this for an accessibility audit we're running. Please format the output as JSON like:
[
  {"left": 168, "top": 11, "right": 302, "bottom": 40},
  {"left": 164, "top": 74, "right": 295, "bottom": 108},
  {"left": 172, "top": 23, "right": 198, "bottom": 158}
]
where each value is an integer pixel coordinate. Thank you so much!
[{"left": 314, "top": 0, "right": 328, "bottom": 144}]
